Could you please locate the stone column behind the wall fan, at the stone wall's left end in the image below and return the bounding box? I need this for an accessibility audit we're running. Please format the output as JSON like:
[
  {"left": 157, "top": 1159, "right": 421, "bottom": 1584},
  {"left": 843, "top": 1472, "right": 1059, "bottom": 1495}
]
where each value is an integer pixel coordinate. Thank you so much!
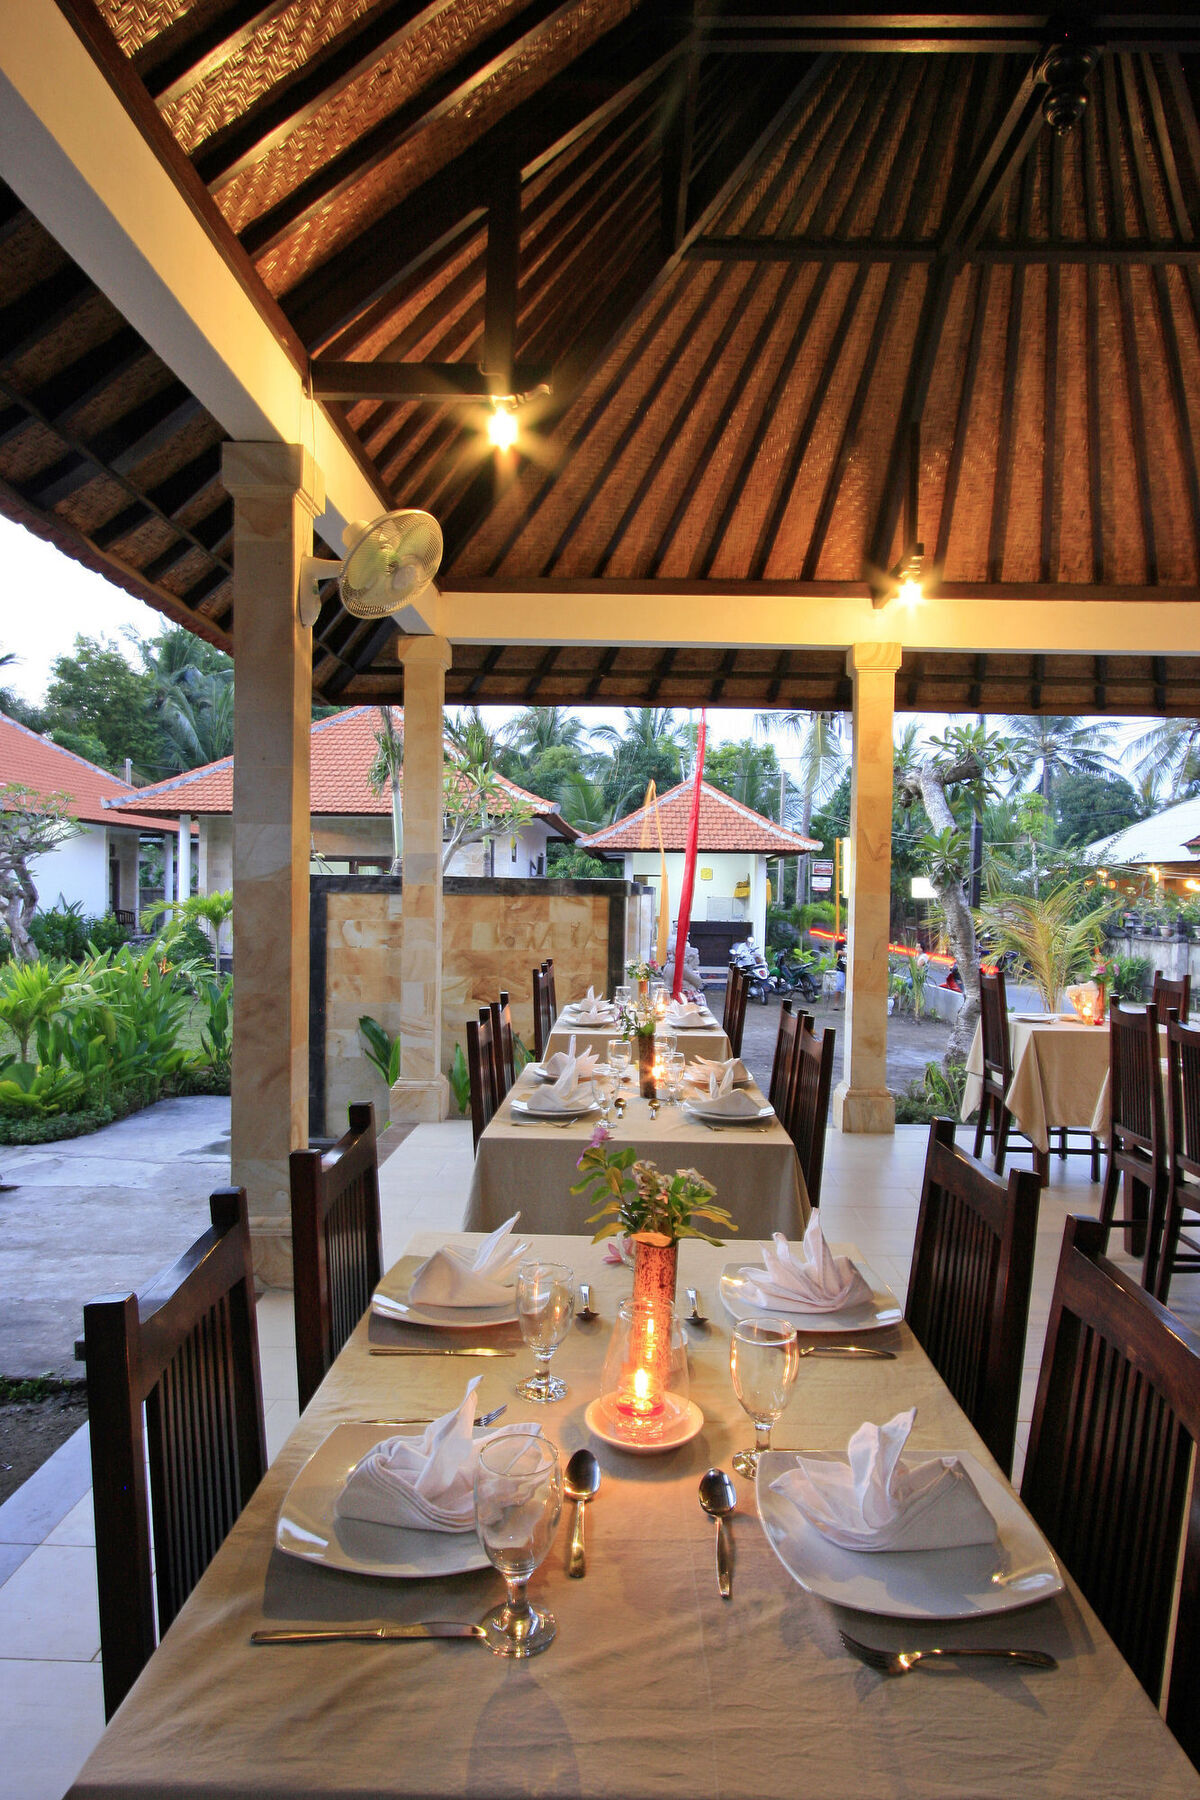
[{"left": 392, "top": 637, "right": 450, "bottom": 1125}]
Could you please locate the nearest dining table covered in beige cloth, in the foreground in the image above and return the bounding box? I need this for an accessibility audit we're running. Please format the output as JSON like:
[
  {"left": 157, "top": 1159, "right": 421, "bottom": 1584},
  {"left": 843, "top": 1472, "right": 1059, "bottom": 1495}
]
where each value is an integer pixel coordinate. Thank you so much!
[{"left": 70, "top": 1231, "right": 1200, "bottom": 1800}]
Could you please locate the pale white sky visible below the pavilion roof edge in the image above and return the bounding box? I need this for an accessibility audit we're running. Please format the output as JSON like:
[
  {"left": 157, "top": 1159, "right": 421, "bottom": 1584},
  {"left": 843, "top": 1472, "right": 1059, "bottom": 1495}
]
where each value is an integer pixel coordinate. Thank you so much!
[{"left": 0, "top": 517, "right": 1150, "bottom": 769}]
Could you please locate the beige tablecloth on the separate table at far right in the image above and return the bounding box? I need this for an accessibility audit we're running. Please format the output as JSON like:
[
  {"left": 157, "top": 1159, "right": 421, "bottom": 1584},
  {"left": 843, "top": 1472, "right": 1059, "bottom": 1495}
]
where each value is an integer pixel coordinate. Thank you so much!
[{"left": 963, "top": 1017, "right": 1108, "bottom": 1150}]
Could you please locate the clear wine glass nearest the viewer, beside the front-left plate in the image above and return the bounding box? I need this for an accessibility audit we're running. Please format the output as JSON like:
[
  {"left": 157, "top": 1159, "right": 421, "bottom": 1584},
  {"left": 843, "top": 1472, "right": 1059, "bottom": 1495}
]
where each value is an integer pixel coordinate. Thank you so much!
[{"left": 475, "top": 1431, "right": 563, "bottom": 1656}]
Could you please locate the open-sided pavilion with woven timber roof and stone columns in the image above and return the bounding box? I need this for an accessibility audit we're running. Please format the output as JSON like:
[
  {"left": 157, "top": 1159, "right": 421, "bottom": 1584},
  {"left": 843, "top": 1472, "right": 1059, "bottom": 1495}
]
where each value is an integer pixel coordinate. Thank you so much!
[{"left": 0, "top": 10, "right": 1200, "bottom": 1273}]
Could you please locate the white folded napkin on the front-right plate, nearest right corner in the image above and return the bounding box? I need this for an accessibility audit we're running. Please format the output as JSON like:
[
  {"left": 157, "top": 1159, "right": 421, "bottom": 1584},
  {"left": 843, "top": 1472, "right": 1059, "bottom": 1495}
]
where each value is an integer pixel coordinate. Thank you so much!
[{"left": 770, "top": 1406, "right": 997, "bottom": 1550}]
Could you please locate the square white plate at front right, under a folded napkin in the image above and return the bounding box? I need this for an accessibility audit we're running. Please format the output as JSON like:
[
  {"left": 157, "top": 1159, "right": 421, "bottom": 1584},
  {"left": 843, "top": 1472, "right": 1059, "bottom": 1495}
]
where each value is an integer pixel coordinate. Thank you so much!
[{"left": 754, "top": 1451, "right": 1063, "bottom": 1618}]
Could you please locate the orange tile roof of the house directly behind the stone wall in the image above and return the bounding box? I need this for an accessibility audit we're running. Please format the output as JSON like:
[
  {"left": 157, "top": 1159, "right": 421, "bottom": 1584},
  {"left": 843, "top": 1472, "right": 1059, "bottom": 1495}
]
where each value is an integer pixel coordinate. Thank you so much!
[{"left": 102, "top": 706, "right": 576, "bottom": 839}]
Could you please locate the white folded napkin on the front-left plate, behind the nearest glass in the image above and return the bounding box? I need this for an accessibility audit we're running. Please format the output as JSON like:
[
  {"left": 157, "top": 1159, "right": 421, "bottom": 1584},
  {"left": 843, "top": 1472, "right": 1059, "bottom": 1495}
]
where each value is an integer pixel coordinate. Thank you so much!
[{"left": 333, "top": 1375, "right": 542, "bottom": 1532}]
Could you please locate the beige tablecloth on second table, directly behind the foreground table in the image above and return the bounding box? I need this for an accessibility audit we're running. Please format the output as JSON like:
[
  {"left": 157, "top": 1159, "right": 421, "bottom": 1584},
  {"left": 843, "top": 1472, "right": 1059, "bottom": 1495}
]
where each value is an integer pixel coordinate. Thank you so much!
[{"left": 466, "top": 1075, "right": 810, "bottom": 1238}]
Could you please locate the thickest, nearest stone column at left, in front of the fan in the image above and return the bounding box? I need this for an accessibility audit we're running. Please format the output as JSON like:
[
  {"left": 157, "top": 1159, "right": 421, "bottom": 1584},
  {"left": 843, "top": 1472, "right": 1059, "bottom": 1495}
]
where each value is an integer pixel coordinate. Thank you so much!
[{"left": 221, "top": 443, "right": 324, "bottom": 1287}]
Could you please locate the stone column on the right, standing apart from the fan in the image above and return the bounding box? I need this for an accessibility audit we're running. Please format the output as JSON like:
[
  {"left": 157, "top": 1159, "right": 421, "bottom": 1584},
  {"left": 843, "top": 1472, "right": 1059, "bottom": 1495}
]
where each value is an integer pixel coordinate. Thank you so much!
[{"left": 833, "top": 644, "right": 900, "bottom": 1132}]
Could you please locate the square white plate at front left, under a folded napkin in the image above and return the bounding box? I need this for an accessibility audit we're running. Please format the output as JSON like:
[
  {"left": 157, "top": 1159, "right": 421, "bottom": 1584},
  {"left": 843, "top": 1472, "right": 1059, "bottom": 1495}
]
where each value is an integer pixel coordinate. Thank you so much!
[{"left": 275, "top": 1424, "right": 489, "bottom": 1580}]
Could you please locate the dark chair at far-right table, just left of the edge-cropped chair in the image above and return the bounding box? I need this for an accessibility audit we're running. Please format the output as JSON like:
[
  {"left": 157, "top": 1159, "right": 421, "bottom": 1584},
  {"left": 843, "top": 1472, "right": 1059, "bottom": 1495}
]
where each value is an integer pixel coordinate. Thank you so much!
[{"left": 1099, "top": 1001, "right": 1168, "bottom": 1292}]
